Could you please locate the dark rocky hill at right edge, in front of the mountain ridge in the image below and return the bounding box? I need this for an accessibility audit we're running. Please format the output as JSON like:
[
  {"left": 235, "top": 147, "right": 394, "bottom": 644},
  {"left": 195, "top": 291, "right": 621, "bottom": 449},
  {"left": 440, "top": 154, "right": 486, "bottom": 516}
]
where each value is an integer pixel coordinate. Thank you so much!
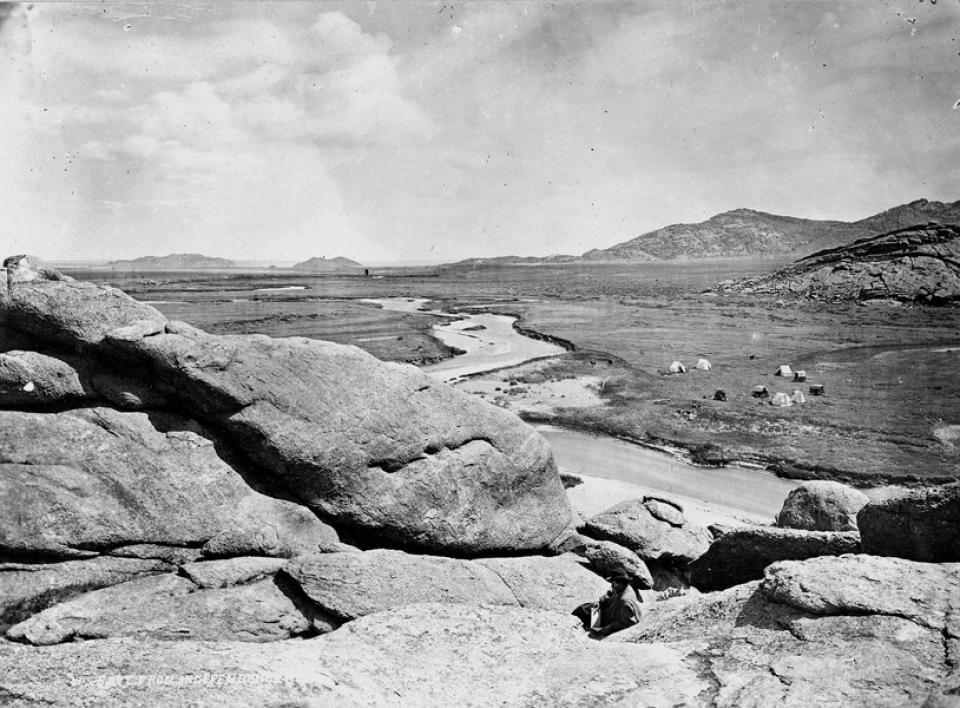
[{"left": 717, "top": 224, "right": 960, "bottom": 305}]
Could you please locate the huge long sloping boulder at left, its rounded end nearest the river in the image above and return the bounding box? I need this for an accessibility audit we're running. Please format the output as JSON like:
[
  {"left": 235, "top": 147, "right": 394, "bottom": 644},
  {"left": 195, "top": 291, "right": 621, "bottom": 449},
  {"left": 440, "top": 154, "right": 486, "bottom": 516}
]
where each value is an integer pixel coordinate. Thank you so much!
[{"left": 0, "top": 257, "right": 572, "bottom": 555}]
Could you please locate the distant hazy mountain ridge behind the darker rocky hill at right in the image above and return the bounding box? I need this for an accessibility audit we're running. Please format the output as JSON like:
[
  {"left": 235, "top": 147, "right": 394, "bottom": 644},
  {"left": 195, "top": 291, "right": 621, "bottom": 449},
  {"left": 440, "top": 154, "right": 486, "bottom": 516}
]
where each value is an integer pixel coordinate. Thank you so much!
[{"left": 440, "top": 199, "right": 960, "bottom": 267}]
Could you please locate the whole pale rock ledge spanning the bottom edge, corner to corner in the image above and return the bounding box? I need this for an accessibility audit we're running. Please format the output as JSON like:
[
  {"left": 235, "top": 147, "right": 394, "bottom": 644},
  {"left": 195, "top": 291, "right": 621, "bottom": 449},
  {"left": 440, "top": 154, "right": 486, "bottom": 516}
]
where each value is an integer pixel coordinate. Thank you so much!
[{"left": 0, "top": 555, "right": 960, "bottom": 708}]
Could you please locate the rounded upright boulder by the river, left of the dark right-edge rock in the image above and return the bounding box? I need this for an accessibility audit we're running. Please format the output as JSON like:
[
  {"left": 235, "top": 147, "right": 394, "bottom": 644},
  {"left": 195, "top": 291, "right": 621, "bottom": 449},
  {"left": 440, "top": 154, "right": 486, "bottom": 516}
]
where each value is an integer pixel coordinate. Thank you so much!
[{"left": 777, "top": 480, "right": 870, "bottom": 531}]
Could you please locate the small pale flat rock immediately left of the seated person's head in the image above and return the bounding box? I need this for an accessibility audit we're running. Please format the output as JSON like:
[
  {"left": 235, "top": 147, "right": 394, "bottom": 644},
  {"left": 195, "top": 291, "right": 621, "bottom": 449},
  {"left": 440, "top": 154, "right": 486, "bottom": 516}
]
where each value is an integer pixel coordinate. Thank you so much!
[{"left": 474, "top": 553, "right": 609, "bottom": 612}]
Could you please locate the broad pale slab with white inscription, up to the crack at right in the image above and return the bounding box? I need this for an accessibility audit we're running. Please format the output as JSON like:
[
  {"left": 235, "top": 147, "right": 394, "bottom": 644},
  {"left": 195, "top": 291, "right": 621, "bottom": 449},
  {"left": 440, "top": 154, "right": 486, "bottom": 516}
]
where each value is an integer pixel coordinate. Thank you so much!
[{"left": 0, "top": 604, "right": 711, "bottom": 708}]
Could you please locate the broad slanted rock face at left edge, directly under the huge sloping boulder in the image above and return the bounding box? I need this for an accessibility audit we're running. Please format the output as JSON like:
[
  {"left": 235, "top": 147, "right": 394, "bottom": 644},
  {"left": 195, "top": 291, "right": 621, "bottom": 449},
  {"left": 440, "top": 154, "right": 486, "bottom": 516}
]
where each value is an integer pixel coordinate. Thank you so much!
[{"left": 0, "top": 408, "right": 338, "bottom": 557}]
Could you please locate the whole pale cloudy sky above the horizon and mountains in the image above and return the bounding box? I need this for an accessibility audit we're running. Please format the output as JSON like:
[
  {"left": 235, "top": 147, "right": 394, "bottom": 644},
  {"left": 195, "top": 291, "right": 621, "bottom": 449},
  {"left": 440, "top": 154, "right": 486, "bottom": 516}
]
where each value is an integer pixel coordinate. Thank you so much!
[{"left": 0, "top": 0, "right": 960, "bottom": 263}]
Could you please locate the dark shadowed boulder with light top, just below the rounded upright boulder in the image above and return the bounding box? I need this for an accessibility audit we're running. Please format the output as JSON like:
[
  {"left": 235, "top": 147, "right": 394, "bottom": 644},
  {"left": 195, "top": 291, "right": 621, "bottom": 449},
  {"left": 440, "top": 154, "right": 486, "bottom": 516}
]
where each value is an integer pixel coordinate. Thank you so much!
[{"left": 688, "top": 526, "right": 860, "bottom": 592}]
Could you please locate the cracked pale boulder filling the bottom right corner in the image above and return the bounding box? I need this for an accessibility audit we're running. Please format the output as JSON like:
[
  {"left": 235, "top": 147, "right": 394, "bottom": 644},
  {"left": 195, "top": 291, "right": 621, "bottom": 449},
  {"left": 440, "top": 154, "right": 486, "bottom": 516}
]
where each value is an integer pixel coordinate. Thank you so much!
[{"left": 605, "top": 555, "right": 960, "bottom": 708}]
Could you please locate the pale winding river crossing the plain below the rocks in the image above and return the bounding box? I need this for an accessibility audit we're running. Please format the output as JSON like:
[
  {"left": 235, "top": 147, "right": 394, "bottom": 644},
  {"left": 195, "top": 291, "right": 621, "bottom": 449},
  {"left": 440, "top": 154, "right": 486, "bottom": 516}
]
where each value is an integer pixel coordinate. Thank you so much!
[{"left": 367, "top": 298, "right": 800, "bottom": 518}]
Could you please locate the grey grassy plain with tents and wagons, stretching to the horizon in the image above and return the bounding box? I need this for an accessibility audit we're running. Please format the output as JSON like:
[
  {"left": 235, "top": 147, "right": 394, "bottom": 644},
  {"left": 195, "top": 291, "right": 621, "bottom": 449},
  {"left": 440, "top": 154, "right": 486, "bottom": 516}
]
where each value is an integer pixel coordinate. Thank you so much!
[{"left": 73, "top": 260, "right": 960, "bottom": 484}]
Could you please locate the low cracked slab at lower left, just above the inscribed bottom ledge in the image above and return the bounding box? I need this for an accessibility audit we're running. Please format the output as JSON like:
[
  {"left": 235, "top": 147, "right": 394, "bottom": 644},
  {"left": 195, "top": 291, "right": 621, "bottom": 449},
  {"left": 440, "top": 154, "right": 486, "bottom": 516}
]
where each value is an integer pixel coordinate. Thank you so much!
[{"left": 7, "top": 574, "right": 329, "bottom": 645}]
